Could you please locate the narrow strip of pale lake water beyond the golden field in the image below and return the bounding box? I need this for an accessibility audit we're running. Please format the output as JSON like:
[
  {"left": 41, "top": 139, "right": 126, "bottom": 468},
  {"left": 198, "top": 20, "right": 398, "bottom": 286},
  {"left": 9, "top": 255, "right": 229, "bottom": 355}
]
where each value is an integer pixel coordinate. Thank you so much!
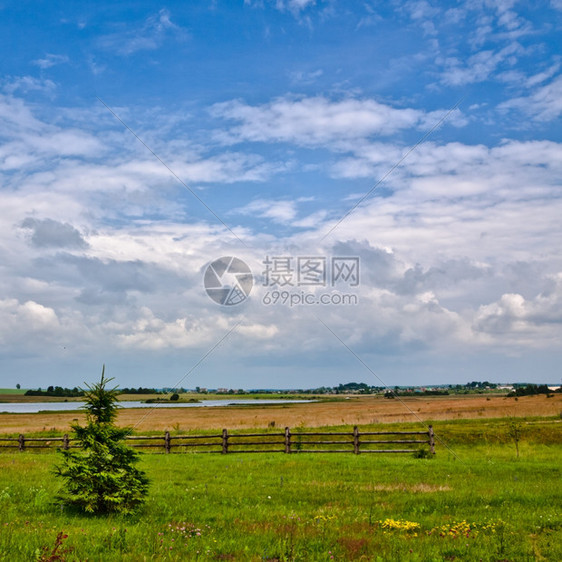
[{"left": 0, "top": 399, "right": 314, "bottom": 414}]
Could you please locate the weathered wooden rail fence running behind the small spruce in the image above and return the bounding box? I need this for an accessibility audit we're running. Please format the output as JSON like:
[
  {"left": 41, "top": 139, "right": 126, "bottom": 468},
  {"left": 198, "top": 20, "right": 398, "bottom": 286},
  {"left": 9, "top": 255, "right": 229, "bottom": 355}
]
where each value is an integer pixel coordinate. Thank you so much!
[{"left": 0, "top": 426, "right": 435, "bottom": 455}]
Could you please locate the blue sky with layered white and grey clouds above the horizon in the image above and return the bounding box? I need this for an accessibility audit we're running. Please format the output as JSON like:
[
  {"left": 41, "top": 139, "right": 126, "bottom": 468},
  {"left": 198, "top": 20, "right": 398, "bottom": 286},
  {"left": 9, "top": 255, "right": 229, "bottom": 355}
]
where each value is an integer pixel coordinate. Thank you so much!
[{"left": 0, "top": 0, "right": 562, "bottom": 389}]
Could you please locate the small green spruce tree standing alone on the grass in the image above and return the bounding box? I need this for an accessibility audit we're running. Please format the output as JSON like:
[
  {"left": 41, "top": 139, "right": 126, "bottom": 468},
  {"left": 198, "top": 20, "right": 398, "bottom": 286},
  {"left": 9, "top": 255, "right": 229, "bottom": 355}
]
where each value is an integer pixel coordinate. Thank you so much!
[{"left": 55, "top": 365, "right": 148, "bottom": 514}]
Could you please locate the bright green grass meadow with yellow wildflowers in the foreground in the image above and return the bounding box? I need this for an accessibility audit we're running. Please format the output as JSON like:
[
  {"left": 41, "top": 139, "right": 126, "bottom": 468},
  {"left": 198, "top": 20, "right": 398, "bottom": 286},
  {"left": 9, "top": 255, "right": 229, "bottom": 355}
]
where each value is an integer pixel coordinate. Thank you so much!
[{"left": 0, "top": 420, "right": 562, "bottom": 562}]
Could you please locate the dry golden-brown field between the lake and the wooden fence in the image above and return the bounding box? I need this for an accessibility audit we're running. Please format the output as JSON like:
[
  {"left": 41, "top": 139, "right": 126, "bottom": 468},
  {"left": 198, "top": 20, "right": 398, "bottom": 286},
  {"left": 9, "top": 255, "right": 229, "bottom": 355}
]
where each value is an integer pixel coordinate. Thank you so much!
[{"left": 0, "top": 394, "right": 562, "bottom": 434}]
